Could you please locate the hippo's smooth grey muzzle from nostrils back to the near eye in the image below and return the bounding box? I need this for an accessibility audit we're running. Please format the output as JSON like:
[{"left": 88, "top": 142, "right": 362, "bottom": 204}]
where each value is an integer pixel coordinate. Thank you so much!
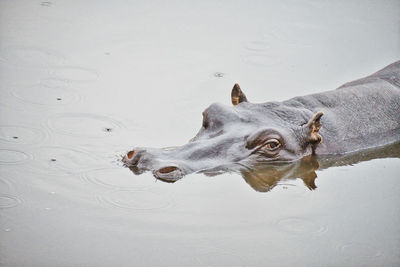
[{"left": 122, "top": 133, "right": 251, "bottom": 182}]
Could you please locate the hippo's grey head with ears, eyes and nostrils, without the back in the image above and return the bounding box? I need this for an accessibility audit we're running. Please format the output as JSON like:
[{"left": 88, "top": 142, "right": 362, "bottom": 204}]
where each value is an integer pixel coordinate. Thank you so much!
[{"left": 123, "top": 84, "right": 323, "bottom": 182}]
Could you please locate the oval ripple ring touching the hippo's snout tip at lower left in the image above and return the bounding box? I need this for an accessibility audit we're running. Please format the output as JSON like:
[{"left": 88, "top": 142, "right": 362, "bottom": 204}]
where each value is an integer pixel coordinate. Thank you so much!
[{"left": 82, "top": 168, "right": 154, "bottom": 190}]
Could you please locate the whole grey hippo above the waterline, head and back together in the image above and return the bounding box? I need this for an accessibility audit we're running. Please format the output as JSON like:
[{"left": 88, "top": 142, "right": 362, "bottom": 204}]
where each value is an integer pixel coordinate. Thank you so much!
[{"left": 123, "top": 61, "right": 400, "bottom": 181}]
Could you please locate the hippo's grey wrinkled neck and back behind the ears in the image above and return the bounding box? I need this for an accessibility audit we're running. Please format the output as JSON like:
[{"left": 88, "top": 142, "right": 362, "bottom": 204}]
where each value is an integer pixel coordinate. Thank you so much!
[{"left": 283, "top": 61, "right": 400, "bottom": 154}]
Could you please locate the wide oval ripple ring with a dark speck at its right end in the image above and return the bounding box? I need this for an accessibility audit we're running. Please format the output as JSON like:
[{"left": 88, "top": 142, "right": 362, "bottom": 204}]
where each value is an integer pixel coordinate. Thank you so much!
[{"left": 48, "top": 113, "right": 123, "bottom": 138}]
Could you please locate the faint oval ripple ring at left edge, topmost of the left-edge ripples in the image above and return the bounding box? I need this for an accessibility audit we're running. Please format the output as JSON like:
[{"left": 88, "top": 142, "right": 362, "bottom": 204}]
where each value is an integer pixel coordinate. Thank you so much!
[{"left": 0, "top": 46, "right": 64, "bottom": 67}]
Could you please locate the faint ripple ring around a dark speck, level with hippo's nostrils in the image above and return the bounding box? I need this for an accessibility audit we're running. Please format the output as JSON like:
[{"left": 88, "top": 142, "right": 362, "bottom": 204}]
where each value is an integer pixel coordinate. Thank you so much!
[{"left": 30, "top": 146, "right": 100, "bottom": 175}]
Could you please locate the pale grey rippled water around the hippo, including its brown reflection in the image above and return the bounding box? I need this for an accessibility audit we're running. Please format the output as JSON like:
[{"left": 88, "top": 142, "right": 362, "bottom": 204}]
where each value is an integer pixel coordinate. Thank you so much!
[{"left": 0, "top": 0, "right": 400, "bottom": 266}]
